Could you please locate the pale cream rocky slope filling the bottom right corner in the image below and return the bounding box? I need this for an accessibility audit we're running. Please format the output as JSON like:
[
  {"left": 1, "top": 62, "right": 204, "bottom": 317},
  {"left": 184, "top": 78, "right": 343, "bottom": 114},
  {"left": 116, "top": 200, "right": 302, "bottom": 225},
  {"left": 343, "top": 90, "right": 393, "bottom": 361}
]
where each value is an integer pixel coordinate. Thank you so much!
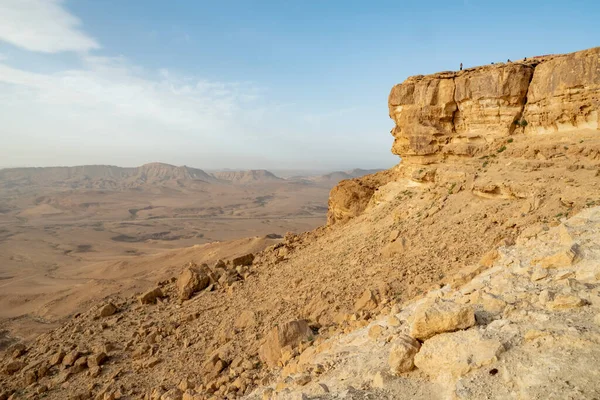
[{"left": 260, "top": 207, "right": 600, "bottom": 399}]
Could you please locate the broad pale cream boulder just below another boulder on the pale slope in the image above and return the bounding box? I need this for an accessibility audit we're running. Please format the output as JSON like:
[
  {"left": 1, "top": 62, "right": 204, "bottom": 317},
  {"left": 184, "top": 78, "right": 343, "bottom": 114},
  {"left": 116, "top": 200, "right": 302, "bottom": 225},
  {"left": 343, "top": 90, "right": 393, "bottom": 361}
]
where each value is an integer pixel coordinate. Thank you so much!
[{"left": 414, "top": 329, "right": 504, "bottom": 377}]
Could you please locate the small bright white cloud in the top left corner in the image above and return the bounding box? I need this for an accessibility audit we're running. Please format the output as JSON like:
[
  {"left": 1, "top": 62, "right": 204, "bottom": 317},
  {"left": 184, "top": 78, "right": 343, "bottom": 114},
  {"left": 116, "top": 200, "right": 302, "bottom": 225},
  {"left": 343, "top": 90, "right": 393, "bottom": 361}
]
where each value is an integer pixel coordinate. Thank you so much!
[{"left": 0, "top": 0, "right": 100, "bottom": 53}]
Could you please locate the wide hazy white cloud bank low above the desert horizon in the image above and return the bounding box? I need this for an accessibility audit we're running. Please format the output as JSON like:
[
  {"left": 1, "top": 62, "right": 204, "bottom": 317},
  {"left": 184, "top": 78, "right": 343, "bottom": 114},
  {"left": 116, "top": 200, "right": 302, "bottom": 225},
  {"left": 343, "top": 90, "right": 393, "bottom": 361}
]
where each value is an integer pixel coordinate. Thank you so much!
[{"left": 0, "top": 53, "right": 267, "bottom": 165}]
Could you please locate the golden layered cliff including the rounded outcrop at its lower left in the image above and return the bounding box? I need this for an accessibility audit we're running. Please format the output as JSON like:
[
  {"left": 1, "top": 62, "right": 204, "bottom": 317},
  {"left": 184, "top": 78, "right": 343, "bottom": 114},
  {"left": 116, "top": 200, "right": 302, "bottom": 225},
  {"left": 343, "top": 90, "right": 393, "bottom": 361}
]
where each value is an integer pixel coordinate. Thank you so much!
[{"left": 328, "top": 47, "right": 600, "bottom": 225}]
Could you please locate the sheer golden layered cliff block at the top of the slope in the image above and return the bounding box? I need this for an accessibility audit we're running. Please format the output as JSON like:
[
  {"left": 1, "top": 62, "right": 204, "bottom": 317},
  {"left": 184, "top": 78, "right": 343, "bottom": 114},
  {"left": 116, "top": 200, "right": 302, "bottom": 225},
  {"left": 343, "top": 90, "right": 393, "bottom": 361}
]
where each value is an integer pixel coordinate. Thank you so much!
[{"left": 388, "top": 48, "right": 600, "bottom": 164}]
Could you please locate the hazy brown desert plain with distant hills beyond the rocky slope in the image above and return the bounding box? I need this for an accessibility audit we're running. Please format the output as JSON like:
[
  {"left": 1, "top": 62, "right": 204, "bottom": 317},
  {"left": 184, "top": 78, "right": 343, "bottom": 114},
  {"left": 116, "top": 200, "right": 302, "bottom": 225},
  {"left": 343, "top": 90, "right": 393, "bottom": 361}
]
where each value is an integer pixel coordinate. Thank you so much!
[{"left": 0, "top": 163, "right": 380, "bottom": 337}]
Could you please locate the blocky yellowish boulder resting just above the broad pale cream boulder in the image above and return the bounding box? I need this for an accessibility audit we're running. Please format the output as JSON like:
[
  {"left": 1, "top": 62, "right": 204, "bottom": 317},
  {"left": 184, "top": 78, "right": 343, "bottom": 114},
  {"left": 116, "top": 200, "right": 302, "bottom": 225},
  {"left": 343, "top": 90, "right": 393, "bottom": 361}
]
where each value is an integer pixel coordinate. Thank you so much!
[{"left": 410, "top": 300, "right": 475, "bottom": 339}]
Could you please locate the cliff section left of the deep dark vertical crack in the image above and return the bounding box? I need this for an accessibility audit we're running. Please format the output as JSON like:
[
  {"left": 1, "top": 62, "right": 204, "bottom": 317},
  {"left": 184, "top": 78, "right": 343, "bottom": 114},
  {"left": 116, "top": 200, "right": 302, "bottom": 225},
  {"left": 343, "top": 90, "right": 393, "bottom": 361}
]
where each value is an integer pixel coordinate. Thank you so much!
[{"left": 388, "top": 63, "right": 533, "bottom": 160}]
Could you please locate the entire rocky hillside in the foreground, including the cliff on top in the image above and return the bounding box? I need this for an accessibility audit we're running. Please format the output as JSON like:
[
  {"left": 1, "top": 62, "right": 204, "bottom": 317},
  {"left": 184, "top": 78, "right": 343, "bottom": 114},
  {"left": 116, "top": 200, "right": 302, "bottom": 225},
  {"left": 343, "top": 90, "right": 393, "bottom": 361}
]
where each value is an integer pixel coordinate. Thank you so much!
[{"left": 0, "top": 49, "right": 600, "bottom": 400}]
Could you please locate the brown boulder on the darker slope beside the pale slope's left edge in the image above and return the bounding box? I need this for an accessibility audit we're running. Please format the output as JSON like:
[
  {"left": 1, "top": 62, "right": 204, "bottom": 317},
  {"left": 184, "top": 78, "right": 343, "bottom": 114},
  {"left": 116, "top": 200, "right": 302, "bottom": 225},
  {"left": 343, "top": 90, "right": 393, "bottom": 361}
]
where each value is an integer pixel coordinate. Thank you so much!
[{"left": 259, "top": 320, "right": 313, "bottom": 367}]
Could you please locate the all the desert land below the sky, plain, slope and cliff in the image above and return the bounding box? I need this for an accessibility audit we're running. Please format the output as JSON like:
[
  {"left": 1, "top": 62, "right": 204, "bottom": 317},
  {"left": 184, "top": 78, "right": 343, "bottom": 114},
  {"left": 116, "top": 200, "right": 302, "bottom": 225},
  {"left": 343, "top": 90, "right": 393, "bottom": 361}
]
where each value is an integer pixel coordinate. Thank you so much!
[{"left": 0, "top": 47, "right": 600, "bottom": 400}]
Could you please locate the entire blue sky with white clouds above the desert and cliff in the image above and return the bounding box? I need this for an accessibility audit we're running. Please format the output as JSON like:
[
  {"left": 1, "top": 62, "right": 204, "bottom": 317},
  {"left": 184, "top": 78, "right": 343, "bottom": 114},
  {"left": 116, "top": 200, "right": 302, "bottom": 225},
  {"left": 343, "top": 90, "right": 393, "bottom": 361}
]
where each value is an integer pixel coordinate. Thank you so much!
[{"left": 0, "top": 0, "right": 600, "bottom": 169}]
